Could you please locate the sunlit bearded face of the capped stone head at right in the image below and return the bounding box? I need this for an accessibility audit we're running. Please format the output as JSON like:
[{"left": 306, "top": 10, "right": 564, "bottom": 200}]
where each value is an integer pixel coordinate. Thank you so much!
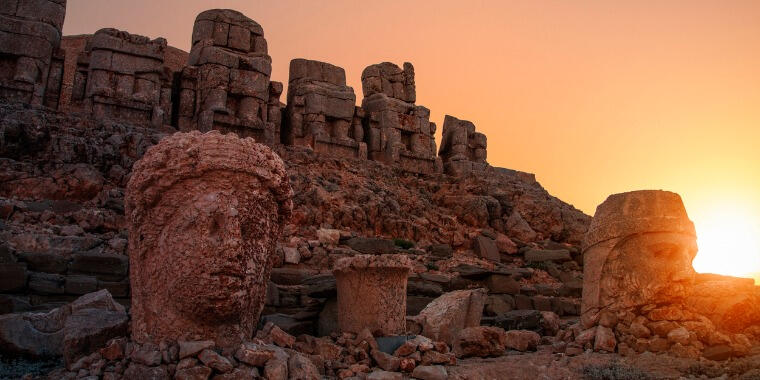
[{"left": 601, "top": 232, "right": 697, "bottom": 307}]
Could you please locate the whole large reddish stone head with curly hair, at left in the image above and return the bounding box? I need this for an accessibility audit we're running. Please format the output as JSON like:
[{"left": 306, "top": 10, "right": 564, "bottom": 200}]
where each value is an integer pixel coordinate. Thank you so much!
[{"left": 125, "top": 131, "right": 292, "bottom": 346}]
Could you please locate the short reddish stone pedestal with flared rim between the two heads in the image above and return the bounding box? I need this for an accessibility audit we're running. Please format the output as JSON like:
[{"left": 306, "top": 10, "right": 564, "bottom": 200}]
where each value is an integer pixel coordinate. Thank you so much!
[{"left": 333, "top": 255, "right": 411, "bottom": 335}]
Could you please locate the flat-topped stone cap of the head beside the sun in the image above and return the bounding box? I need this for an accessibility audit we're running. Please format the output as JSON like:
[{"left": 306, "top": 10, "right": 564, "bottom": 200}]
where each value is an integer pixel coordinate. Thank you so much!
[{"left": 583, "top": 190, "right": 696, "bottom": 250}]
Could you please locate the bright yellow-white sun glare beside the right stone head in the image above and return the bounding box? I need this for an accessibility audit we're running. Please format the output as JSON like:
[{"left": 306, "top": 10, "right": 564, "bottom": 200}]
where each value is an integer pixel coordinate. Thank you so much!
[{"left": 693, "top": 205, "right": 760, "bottom": 284}]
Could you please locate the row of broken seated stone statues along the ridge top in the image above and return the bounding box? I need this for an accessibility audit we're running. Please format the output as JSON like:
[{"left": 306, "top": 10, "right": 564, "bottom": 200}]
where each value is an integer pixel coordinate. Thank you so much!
[{"left": 0, "top": 0, "right": 488, "bottom": 175}]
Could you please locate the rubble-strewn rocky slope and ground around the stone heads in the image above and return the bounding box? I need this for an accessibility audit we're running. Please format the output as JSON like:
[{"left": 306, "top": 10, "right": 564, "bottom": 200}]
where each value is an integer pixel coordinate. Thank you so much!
[{"left": 0, "top": 100, "right": 760, "bottom": 379}]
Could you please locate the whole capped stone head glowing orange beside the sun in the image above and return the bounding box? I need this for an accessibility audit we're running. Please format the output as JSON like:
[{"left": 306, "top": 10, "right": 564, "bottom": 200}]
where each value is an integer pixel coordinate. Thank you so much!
[{"left": 581, "top": 190, "right": 697, "bottom": 328}]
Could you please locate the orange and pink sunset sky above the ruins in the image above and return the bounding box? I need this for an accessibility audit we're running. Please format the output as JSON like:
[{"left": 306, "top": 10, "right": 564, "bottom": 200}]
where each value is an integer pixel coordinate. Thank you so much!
[{"left": 64, "top": 0, "right": 760, "bottom": 280}]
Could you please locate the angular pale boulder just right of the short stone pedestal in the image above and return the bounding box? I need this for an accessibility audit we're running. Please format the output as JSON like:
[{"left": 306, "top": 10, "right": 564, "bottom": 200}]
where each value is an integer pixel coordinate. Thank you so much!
[{"left": 416, "top": 289, "right": 487, "bottom": 345}]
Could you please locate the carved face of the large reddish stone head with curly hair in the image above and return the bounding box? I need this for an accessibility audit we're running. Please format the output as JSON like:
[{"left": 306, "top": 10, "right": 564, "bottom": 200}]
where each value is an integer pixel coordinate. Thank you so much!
[{"left": 154, "top": 179, "right": 277, "bottom": 321}]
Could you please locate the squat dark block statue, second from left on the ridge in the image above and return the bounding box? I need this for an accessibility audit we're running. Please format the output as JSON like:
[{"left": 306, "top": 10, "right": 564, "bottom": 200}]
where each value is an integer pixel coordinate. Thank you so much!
[{"left": 71, "top": 29, "right": 172, "bottom": 128}]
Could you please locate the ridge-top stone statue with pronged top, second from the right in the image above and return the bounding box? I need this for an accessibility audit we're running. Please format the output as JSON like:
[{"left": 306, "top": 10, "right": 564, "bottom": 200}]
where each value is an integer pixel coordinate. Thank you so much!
[{"left": 362, "top": 62, "right": 442, "bottom": 174}]
